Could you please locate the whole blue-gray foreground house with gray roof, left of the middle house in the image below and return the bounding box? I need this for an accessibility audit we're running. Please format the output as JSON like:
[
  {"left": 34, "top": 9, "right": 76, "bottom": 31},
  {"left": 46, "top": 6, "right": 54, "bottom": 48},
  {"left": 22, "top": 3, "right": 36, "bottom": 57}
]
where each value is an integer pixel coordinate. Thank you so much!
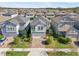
[{"left": 1, "top": 16, "right": 30, "bottom": 37}]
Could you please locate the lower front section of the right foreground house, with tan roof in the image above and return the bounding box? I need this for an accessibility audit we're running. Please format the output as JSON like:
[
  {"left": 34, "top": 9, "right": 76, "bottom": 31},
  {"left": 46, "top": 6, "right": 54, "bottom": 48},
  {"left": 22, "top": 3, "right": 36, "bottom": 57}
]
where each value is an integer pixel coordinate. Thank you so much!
[{"left": 58, "top": 24, "right": 79, "bottom": 38}]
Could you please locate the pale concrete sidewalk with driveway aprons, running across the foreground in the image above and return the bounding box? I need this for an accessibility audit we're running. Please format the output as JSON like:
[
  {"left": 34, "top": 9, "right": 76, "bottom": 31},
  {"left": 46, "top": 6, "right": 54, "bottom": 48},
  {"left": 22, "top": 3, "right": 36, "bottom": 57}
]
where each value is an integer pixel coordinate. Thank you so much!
[{"left": 0, "top": 48, "right": 79, "bottom": 56}]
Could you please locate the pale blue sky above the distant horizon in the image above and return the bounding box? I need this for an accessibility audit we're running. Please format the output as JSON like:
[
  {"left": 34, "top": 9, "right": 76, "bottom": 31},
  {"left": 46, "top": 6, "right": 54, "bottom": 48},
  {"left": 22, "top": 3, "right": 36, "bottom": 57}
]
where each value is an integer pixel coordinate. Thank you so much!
[{"left": 0, "top": 2, "right": 79, "bottom": 8}]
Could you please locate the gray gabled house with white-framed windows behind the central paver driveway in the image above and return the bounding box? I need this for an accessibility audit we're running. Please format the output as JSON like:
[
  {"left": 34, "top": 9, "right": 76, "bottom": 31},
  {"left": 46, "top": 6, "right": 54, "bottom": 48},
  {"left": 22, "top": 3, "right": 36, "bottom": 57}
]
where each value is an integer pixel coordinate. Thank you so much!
[{"left": 30, "top": 16, "right": 50, "bottom": 36}]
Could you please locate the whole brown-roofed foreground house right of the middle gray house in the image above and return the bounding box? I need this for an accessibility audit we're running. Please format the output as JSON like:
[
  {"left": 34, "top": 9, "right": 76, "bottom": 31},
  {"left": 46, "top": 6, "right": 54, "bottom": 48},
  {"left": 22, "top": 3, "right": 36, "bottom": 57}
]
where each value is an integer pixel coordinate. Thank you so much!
[{"left": 52, "top": 16, "right": 78, "bottom": 38}]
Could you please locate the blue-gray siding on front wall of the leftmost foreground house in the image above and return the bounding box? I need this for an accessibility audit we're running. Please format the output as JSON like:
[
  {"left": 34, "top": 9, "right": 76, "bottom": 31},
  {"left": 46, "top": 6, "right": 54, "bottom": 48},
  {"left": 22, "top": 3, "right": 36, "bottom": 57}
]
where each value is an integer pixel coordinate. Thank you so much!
[{"left": 1, "top": 21, "right": 17, "bottom": 37}]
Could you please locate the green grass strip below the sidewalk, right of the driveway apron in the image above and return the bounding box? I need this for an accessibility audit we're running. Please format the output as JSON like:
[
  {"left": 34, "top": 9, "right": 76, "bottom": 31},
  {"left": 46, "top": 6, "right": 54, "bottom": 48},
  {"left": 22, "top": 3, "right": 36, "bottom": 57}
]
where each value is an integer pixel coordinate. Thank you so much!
[{"left": 47, "top": 51, "right": 78, "bottom": 56}]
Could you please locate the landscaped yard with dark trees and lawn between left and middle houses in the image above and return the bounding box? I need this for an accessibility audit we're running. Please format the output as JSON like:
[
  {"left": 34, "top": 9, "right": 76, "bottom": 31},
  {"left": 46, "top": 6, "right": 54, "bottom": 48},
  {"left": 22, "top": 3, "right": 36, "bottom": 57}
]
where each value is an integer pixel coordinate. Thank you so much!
[{"left": 10, "top": 28, "right": 32, "bottom": 48}]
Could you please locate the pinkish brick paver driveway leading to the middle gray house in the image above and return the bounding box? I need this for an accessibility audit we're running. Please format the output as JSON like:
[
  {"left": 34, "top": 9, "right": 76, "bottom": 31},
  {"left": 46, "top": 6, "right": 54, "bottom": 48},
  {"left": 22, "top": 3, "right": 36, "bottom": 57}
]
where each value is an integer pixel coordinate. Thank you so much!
[{"left": 31, "top": 37, "right": 45, "bottom": 48}]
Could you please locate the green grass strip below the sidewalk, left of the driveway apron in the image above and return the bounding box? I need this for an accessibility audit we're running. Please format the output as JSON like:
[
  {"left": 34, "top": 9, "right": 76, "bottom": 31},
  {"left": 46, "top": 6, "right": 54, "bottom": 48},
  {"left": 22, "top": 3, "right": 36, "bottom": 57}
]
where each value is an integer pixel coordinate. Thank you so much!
[{"left": 6, "top": 51, "right": 29, "bottom": 56}]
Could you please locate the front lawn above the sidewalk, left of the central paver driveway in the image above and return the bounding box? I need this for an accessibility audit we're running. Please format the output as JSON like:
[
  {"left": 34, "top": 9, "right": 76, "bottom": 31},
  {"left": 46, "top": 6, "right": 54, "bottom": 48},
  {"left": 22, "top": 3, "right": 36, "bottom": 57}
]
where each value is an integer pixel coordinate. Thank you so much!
[{"left": 12, "top": 37, "right": 31, "bottom": 48}]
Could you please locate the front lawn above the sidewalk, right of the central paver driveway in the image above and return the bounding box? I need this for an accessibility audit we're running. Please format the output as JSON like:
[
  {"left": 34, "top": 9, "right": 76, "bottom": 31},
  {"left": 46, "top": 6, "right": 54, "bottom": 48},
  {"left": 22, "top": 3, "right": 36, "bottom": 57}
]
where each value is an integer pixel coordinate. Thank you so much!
[{"left": 45, "top": 36, "right": 75, "bottom": 48}]
